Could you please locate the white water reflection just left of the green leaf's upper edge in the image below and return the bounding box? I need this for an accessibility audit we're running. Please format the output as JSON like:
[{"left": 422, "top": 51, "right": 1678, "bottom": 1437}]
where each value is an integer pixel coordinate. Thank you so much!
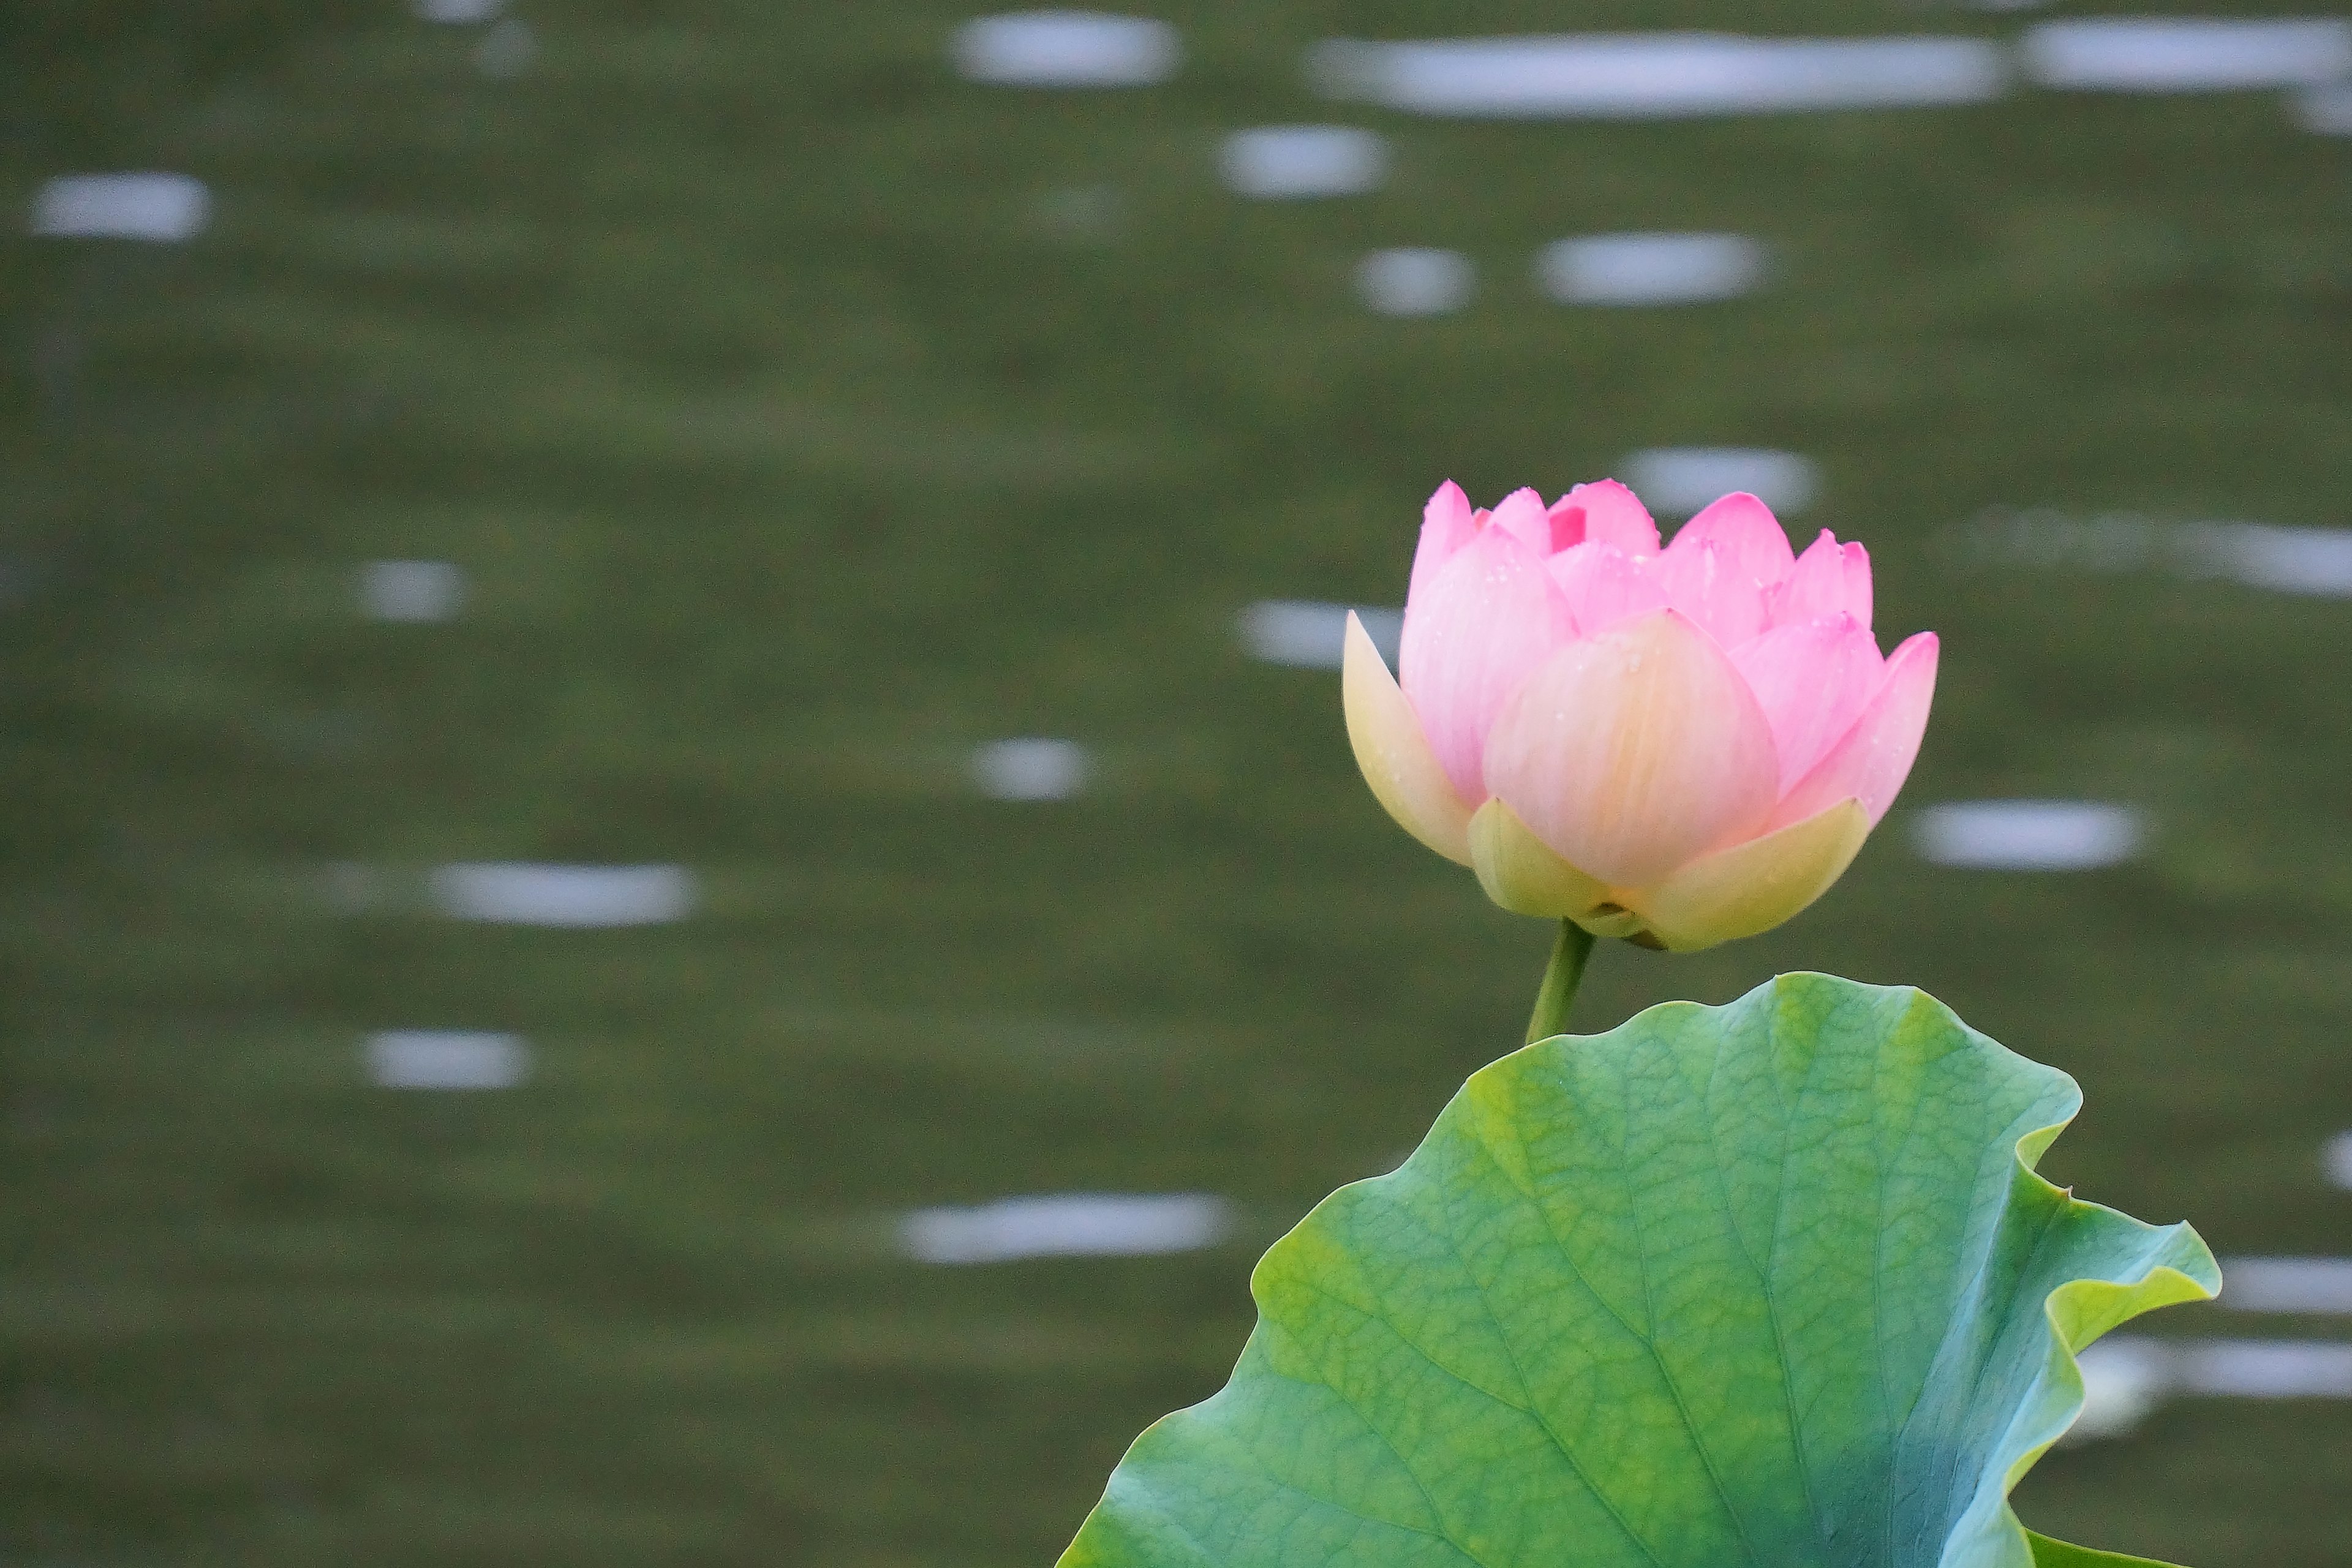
[{"left": 899, "top": 1192, "right": 1232, "bottom": 1262}]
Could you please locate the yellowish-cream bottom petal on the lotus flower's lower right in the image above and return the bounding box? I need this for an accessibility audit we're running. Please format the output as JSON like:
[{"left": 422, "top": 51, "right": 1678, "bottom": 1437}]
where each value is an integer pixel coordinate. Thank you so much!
[{"left": 1625, "top": 799, "right": 1870, "bottom": 952}]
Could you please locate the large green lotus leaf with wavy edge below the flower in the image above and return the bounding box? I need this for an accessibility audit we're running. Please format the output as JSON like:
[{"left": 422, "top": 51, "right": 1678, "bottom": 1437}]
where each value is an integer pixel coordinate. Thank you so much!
[{"left": 1063, "top": 976, "right": 2220, "bottom": 1568}]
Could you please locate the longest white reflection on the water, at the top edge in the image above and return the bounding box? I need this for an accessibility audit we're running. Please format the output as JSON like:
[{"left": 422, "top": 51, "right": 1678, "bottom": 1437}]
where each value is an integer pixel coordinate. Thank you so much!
[{"left": 1308, "top": 33, "right": 2008, "bottom": 120}]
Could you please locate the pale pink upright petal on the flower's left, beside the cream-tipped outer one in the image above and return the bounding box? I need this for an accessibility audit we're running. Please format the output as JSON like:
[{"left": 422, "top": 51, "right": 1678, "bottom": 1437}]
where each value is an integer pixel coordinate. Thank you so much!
[{"left": 1397, "top": 526, "right": 1574, "bottom": 804}]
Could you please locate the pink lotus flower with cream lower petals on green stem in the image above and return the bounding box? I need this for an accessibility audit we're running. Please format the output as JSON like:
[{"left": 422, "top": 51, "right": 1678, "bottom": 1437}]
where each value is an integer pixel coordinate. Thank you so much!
[{"left": 1343, "top": 480, "right": 1936, "bottom": 952}]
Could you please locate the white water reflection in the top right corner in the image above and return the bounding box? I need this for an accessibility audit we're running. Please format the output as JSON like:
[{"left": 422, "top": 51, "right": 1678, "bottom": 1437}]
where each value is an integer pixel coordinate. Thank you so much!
[{"left": 2018, "top": 17, "right": 2352, "bottom": 92}]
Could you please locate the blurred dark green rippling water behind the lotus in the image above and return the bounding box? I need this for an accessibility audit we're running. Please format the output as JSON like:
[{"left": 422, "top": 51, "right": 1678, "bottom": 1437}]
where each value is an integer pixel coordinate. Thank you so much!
[{"left": 0, "top": 0, "right": 2352, "bottom": 1568}]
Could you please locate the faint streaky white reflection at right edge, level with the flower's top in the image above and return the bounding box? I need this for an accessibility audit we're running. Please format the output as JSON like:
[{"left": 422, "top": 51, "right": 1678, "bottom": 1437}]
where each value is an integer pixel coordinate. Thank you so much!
[{"left": 1943, "top": 505, "right": 2352, "bottom": 600}]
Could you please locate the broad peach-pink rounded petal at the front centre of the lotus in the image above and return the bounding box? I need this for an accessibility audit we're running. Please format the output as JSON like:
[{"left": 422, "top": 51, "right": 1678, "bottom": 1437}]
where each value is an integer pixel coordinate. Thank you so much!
[{"left": 1487, "top": 611, "right": 1776, "bottom": 886}]
